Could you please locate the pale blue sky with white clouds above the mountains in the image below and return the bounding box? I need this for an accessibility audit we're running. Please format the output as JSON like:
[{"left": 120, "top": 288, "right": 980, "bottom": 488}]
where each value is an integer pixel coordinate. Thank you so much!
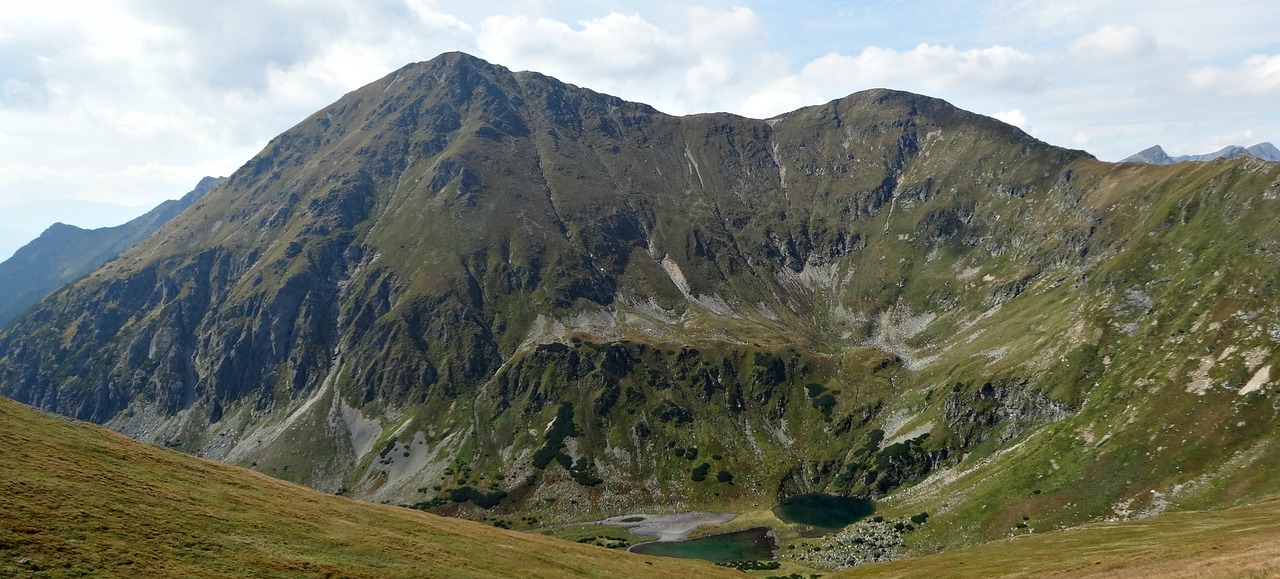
[{"left": 0, "top": 0, "right": 1280, "bottom": 259}]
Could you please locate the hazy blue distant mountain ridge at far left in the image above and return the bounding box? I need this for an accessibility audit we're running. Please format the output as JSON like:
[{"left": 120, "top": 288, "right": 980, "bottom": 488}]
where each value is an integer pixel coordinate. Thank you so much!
[{"left": 0, "top": 177, "right": 223, "bottom": 327}]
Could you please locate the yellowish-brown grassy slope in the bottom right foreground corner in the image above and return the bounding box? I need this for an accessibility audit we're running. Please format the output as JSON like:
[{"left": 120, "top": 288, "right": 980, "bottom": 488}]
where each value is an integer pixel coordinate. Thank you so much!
[{"left": 833, "top": 497, "right": 1280, "bottom": 579}]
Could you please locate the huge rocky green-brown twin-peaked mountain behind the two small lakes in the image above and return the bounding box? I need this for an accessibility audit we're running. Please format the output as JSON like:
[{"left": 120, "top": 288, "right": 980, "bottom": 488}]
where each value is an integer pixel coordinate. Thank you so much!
[{"left": 0, "top": 54, "right": 1280, "bottom": 566}]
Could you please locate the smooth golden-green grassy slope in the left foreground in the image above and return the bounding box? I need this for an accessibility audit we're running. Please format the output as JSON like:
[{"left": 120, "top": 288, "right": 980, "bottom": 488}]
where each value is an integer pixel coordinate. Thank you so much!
[{"left": 0, "top": 398, "right": 740, "bottom": 578}]
